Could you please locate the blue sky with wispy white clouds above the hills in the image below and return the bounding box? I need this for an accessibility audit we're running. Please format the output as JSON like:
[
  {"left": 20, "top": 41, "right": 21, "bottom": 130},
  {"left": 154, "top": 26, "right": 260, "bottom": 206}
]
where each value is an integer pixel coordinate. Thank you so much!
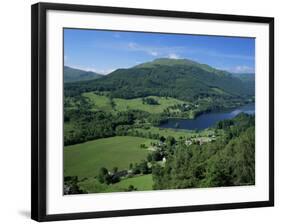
[{"left": 64, "top": 29, "right": 255, "bottom": 74}]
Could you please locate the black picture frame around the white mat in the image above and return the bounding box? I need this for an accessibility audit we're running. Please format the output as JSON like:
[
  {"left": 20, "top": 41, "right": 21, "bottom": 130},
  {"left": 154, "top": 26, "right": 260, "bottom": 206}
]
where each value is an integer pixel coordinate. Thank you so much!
[{"left": 31, "top": 3, "right": 274, "bottom": 221}]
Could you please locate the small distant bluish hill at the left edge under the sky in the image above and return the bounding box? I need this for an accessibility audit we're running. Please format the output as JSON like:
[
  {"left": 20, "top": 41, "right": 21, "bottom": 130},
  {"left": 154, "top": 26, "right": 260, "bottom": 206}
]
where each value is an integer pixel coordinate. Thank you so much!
[{"left": 63, "top": 66, "right": 102, "bottom": 83}]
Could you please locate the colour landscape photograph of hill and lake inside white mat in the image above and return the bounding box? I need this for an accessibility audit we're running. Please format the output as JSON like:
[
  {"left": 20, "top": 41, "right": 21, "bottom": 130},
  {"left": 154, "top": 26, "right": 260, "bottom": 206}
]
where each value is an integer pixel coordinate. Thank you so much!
[{"left": 61, "top": 28, "right": 255, "bottom": 195}]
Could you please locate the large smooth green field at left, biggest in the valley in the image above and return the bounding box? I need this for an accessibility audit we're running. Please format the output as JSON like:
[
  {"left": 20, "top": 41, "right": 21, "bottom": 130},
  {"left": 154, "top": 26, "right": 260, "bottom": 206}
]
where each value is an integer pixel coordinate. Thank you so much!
[{"left": 64, "top": 136, "right": 153, "bottom": 179}]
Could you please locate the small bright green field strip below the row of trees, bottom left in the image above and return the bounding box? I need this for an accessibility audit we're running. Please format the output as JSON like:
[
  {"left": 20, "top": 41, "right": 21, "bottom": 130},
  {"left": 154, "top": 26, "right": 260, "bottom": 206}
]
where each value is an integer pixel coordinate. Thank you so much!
[{"left": 79, "top": 174, "right": 153, "bottom": 193}]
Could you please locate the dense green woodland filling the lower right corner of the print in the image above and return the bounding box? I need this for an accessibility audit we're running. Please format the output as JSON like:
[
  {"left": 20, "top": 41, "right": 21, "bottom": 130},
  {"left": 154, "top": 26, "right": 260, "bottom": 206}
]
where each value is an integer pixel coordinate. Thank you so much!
[{"left": 152, "top": 114, "right": 255, "bottom": 189}]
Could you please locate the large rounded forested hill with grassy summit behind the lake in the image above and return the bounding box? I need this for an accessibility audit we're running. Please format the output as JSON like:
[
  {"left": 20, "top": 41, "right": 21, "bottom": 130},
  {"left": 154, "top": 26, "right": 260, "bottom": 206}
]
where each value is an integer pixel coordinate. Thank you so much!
[{"left": 65, "top": 58, "right": 254, "bottom": 100}]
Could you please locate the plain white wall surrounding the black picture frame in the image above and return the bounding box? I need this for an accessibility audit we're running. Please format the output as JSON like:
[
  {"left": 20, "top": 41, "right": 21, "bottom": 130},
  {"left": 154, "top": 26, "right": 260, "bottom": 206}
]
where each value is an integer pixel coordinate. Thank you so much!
[{"left": 0, "top": 0, "right": 281, "bottom": 224}]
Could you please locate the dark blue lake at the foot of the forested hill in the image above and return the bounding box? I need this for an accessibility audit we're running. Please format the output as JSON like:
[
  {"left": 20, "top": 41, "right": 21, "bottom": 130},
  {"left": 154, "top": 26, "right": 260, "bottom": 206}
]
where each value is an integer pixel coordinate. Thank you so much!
[{"left": 160, "top": 104, "right": 255, "bottom": 130}]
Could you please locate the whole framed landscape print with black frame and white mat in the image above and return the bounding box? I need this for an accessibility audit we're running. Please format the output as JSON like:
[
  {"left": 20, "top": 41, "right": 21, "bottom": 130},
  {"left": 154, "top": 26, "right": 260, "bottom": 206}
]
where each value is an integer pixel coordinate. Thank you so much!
[{"left": 32, "top": 3, "right": 274, "bottom": 221}]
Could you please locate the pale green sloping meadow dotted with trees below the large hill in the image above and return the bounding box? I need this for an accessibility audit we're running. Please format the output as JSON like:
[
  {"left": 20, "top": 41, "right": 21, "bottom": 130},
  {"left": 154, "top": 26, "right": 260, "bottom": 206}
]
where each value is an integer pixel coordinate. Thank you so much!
[{"left": 83, "top": 92, "right": 184, "bottom": 113}]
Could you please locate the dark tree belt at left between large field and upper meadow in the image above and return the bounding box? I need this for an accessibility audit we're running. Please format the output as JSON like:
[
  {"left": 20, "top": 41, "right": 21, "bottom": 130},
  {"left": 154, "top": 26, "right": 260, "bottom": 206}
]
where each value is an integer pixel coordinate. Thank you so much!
[{"left": 64, "top": 97, "right": 148, "bottom": 146}]
